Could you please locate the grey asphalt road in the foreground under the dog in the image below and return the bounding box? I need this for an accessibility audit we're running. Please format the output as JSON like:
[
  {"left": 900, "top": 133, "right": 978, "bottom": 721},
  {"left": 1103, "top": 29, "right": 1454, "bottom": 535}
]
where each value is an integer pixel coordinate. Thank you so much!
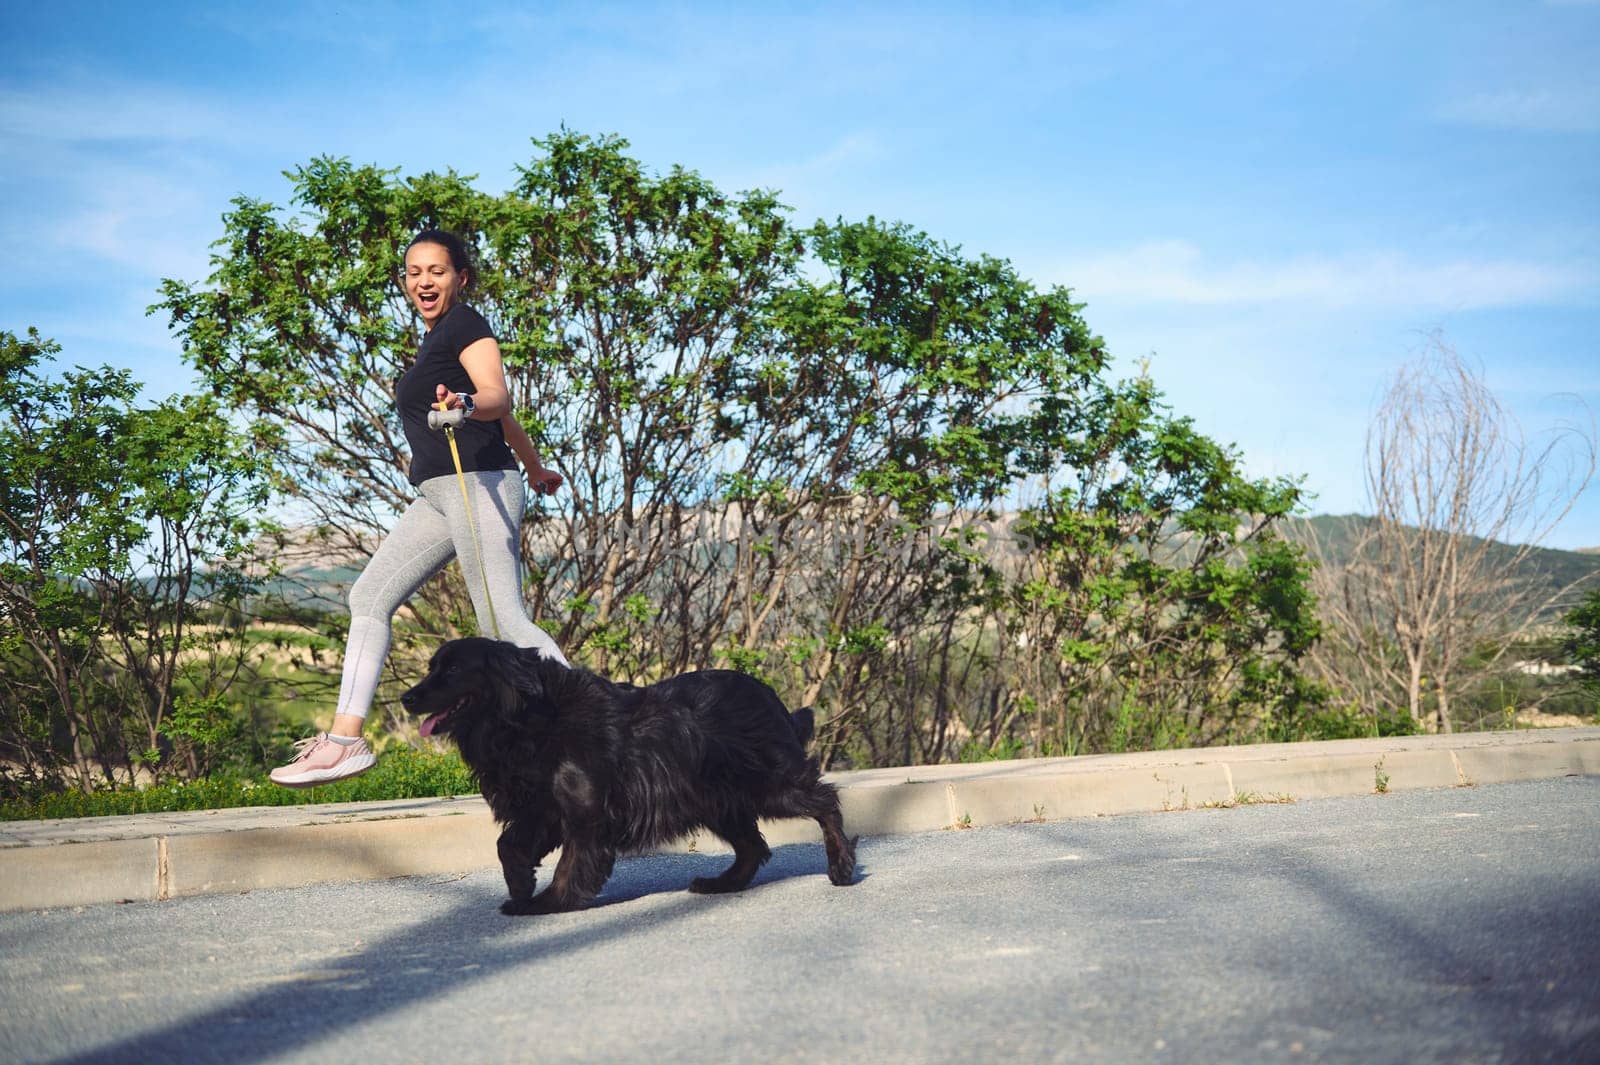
[{"left": 0, "top": 777, "right": 1600, "bottom": 1065}]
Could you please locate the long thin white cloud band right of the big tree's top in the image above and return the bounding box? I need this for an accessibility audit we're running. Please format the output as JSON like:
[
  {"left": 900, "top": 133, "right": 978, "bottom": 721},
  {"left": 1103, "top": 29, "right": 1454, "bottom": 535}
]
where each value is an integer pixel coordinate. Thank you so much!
[{"left": 1045, "top": 240, "right": 1600, "bottom": 310}]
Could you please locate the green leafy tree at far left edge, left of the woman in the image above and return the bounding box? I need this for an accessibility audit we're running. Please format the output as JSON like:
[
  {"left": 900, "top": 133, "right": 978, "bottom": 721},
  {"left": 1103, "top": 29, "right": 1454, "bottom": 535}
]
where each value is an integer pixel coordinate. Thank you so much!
[{"left": 0, "top": 331, "right": 264, "bottom": 788}]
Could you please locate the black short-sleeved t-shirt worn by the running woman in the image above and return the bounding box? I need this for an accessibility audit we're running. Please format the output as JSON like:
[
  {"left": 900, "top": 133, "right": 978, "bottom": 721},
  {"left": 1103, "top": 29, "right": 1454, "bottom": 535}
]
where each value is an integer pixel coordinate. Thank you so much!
[{"left": 395, "top": 304, "right": 517, "bottom": 485}]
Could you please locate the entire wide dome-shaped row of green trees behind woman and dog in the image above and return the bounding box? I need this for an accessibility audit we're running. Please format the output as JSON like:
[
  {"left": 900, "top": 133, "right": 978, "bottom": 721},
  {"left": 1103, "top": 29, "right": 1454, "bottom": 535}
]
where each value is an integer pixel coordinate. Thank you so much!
[{"left": 158, "top": 131, "right": 1315, "bottom": 764}]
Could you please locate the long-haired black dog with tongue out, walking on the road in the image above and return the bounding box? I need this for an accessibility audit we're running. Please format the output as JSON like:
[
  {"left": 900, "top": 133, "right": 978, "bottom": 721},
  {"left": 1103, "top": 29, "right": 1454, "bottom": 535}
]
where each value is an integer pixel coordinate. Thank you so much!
[{"left": 402, "top": 640, "right": 856, "bottom": 913}]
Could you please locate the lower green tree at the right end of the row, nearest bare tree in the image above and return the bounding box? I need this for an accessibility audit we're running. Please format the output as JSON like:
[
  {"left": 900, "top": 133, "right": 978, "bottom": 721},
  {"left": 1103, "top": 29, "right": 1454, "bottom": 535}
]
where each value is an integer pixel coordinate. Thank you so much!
[{"left": 990, "top": 367, "right": 1320, "bottom": 752}]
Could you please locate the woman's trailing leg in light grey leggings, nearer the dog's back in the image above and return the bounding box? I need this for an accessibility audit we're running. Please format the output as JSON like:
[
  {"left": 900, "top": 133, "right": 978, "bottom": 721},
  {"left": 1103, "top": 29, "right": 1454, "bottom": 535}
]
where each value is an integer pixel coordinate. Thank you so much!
[{"left": 422, "top": 470, "right": 568, "bottom": 665}]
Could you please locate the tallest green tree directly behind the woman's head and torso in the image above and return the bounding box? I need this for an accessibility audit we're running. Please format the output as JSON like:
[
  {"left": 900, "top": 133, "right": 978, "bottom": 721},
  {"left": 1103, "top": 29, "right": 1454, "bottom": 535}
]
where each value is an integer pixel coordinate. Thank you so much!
[{"left": 162, "top": 134, "right": 800, "bottom": 687}]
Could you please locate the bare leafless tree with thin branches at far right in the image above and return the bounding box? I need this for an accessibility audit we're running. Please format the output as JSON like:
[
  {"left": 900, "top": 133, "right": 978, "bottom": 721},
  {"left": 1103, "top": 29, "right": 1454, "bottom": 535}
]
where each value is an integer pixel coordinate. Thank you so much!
[{"left": 1314, "top": 334, "right": 1595, "bottom": 732}]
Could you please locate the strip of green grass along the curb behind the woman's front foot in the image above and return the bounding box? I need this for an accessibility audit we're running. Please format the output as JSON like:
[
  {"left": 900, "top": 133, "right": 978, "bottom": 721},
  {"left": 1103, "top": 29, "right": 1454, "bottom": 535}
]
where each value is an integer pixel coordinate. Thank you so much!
[{"left": 0, "top": 747, "right": 478, "bottom": 820}]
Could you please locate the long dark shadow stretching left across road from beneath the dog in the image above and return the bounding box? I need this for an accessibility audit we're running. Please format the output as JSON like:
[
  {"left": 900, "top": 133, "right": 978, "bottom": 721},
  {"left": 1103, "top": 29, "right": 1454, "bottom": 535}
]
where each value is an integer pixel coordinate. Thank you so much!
[{"left": 51, "top": 843, "right": 862, "bottom": 1065}]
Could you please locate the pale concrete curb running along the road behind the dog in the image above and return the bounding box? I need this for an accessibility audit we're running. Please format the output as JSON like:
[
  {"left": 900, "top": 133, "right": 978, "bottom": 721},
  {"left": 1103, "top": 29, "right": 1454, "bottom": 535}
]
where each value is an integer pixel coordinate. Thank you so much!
[{"left": 0, "top": 728, "right": 1600, "bottom": 911}]
